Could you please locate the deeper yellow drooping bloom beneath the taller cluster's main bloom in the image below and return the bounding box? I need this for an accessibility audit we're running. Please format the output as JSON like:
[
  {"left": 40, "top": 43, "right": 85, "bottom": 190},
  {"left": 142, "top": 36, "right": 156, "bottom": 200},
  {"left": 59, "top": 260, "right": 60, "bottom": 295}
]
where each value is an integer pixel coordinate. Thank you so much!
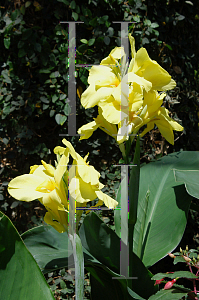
[{"left": 78, "top": 90, "right": 183, "bottom": 145}]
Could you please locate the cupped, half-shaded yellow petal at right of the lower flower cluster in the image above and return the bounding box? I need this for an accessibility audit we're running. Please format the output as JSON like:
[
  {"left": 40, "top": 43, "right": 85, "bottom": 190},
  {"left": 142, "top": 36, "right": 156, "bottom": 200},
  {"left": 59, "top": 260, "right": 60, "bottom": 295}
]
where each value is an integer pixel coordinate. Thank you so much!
[{"left": 69, "top": 178, "right": 97, "bottom": 203}]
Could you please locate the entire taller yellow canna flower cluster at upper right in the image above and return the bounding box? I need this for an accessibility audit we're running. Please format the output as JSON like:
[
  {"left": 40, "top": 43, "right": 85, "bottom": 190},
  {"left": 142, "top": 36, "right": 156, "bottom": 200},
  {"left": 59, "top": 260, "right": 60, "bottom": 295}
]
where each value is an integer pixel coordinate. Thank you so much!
[{"left": 78, "top": 34, "right": 183, "bottom": 144}]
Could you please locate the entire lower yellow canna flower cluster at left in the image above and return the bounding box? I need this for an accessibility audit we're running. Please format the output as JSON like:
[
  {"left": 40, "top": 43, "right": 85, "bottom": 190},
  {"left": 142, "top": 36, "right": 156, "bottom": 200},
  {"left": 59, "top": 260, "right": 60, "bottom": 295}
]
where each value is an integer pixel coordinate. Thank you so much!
[{"left": 8, "top": 139, "right": 118, "bottom": 232}]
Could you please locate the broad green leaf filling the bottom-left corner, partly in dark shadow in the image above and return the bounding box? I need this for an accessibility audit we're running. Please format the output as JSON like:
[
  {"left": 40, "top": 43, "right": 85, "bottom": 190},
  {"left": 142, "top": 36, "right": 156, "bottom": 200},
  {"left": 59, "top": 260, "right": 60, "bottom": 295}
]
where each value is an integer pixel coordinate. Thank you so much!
[{"left": 0, "top": 212, "right": 54, "bottom": 300}]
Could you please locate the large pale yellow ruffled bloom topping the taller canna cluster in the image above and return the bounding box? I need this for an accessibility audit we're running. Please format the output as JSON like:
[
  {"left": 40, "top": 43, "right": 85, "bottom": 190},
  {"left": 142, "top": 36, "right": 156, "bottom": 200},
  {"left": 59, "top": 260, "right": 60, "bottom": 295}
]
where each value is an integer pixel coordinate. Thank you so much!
[{"left": 81, "top": 35, "right": 176, "bottom": 124}]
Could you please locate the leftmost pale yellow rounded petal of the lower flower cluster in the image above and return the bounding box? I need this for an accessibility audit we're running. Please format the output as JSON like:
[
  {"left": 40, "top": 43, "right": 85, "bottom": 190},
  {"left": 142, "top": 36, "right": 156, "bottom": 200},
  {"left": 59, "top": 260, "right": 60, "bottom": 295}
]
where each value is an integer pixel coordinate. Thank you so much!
[{"left": 8, "top": 174, "right": 46, "bottom": 201}]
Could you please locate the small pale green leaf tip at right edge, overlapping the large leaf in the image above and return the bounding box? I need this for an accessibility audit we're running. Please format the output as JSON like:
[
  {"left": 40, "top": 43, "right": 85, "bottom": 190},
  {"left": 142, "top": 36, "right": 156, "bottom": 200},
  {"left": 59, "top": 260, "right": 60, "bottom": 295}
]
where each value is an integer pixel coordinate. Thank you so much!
[{"left": 174, "top": 170, "right": 199, "bottom": 199}]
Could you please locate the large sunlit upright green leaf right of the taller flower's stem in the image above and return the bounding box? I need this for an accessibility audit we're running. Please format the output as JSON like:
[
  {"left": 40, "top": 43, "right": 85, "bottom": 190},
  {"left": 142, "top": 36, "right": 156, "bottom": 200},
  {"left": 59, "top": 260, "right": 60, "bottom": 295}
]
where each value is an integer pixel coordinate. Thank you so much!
[{"left": 133, "top": 151, "right": 194, "bottom": 267}]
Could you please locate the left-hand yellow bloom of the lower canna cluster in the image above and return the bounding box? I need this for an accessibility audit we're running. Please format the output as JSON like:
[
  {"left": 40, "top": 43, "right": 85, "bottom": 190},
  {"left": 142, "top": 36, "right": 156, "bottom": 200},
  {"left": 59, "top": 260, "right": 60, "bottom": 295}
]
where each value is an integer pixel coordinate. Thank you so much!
[{"left": 8, "top": 150, "right": 69, "bottom": 232}]
